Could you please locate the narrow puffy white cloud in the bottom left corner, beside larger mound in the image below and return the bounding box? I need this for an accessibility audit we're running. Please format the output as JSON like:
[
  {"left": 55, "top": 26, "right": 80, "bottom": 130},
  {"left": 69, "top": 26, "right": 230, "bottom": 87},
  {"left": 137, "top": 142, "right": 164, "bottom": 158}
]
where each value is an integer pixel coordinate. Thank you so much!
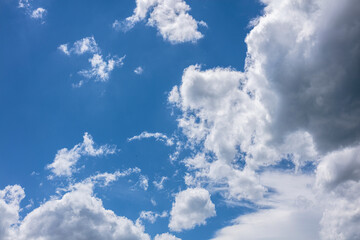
[{"left": 0, "top": 185, "right": 25, "bottom": 240}]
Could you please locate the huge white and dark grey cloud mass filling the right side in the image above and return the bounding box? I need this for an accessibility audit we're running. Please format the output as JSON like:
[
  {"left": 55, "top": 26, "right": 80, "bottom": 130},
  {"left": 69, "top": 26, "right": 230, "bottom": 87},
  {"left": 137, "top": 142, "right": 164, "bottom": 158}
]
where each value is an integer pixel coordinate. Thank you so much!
[{"left": 165, "top": 0, "right": 360, "bottom": 240}]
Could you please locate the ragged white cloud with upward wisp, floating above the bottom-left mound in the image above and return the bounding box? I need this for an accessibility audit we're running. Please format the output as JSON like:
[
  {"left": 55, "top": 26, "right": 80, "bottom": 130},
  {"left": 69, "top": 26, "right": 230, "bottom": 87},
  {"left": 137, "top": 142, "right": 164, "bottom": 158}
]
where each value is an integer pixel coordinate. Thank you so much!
[{"left": 47, "top": 133, "right": 116, "bottom": 177}]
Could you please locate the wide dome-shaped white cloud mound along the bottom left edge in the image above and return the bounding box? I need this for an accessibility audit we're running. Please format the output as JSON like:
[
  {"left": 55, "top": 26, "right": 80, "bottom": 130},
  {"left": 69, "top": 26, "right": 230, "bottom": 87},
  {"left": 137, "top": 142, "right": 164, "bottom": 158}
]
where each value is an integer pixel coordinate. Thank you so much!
[{"left": 17, "top": 178, "right": 150, "bottom": 240}]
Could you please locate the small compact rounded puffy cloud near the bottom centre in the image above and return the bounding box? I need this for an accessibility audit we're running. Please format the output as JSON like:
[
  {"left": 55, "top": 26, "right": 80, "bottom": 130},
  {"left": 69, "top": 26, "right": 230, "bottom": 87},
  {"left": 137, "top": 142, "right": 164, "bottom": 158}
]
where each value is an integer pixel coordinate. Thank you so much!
[{"left": 169, "top": 188, "right": 216, "bottom": 231}]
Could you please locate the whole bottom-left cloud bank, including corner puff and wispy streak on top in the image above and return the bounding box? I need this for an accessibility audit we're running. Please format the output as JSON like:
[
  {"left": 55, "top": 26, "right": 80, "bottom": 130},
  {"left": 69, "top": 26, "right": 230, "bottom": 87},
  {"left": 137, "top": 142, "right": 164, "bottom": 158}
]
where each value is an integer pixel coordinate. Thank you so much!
[{"left": 0, "top": 168, "right": 150, "bottom": 240}]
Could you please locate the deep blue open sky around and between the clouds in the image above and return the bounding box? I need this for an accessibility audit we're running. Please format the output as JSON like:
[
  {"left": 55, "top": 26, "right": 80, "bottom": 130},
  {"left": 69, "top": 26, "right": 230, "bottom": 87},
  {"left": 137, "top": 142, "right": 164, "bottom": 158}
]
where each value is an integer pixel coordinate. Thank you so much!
[{"left": 0, "top": 0, "right": 262, "bottom": 239}]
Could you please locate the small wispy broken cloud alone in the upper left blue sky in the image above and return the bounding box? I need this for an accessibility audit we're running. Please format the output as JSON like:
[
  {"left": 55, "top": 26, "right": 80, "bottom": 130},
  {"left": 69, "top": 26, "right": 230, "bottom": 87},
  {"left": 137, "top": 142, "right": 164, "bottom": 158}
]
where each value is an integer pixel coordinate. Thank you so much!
[{"left": 58, "top": 37, "right": 125, "bottom": 84}]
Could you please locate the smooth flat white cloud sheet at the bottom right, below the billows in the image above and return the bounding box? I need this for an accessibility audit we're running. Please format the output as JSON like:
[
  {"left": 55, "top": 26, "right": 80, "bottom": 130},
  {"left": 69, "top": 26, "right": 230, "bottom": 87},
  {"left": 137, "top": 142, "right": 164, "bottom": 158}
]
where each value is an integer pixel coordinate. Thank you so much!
[{"left": 213, "top": 172, "right": 322, "bottom": 240}]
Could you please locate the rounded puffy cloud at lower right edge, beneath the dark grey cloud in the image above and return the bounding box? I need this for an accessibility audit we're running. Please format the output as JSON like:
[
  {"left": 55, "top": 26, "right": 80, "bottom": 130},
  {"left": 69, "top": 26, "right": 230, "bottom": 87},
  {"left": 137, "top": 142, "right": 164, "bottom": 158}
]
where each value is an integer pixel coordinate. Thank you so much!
[{"left": 316, "top": 145, "right": 360, "bottom": 240}]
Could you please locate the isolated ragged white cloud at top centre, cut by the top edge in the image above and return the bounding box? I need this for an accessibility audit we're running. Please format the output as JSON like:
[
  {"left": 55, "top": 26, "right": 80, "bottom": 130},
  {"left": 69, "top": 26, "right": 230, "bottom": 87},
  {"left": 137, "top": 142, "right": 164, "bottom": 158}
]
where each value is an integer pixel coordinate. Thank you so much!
[{"left": 113, "top": 0, "right": 206, "bottom": 44}]
